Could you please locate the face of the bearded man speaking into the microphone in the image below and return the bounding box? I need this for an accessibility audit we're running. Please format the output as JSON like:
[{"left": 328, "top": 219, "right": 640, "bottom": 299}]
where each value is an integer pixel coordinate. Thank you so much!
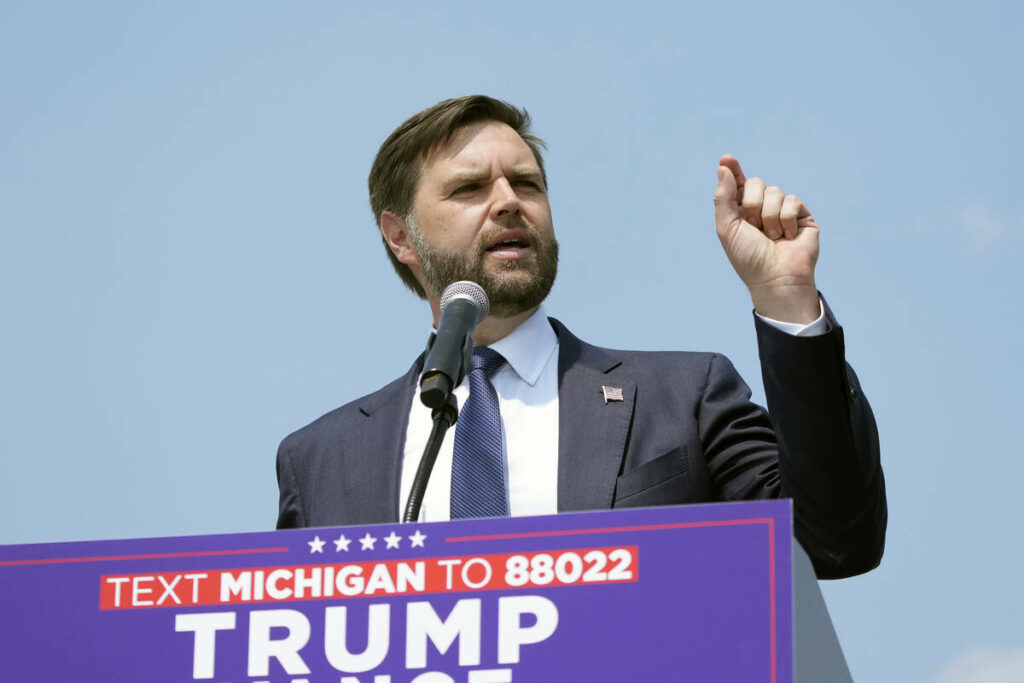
[{"left": 406, "top": 122, "right": 558, "bottom": 317}]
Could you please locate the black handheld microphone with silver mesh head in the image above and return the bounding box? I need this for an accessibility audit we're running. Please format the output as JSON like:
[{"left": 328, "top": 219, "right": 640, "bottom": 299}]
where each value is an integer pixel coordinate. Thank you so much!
[{"left": 420, "top": 280, "right": 490, "bottom": 410}]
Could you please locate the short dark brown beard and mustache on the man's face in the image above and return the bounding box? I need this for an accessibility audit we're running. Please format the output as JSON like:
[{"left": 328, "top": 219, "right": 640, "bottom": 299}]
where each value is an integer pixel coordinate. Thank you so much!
[{"left": 417, "top": 230, "right": 558, "bottom": 317}]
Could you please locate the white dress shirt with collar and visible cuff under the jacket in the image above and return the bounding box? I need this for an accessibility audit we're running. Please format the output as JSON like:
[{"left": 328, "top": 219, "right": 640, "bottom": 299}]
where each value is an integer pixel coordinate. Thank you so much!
[{"left": 398, "top": 306, "right": 829, "bottom": 521}]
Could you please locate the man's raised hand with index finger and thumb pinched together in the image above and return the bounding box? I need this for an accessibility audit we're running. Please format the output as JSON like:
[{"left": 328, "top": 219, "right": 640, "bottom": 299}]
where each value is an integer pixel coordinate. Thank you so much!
[{"left": 715, "top": 155, "right": 820, "bottom": 324}]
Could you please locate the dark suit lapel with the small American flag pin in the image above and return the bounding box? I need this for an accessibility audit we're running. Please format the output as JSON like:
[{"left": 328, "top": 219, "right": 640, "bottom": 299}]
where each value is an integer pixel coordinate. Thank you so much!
[{"left": 551, "top": 318, "right": 636, "bottom": 512}]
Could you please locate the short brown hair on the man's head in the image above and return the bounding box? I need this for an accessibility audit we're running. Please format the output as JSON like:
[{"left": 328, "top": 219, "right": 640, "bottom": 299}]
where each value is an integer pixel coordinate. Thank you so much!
[{"left": 369, "top": 95, "right": 548, "bottom": 299}]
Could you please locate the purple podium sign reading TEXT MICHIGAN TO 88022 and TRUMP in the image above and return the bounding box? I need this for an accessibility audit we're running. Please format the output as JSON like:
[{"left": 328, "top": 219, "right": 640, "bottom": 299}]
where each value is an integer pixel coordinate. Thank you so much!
[{"left": 0, "top": 501, "right": 793, "bottom": 683}]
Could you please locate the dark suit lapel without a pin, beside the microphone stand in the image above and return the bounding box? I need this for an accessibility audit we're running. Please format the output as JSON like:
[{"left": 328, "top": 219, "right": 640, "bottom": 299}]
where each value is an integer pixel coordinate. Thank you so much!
[{"left": 349, "top": 355, "right": 423, "bottom": 523}]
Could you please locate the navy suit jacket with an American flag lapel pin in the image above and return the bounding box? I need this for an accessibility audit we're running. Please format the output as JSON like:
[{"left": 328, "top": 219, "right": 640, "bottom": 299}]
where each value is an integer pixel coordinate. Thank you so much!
[{"left": 278, "top": 307, "right": 887, "bottom": 578}]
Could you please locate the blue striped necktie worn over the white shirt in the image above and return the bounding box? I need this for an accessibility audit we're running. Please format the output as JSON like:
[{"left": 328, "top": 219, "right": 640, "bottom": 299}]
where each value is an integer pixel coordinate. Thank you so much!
[{"left": 451, "top": 346, "right": 509, "bottom": 519}]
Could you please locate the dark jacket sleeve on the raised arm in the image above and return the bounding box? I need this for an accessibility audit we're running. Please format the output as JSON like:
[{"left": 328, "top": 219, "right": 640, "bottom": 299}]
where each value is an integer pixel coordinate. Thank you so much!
[{"left": 755, "top": 305, "right": 888, "bottom": 579}]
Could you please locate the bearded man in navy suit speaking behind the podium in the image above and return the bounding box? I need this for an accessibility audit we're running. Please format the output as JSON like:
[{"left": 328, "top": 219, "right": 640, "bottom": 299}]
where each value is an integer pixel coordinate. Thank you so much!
[{"left": 278, "top": 96, "right": 886, "bottom": 578}]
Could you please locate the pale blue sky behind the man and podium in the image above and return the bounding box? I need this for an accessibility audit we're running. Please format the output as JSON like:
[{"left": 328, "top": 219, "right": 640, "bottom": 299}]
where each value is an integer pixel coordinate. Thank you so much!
[{"left": 0, "top": 1, "right": 1024, "bottom": 683}]
